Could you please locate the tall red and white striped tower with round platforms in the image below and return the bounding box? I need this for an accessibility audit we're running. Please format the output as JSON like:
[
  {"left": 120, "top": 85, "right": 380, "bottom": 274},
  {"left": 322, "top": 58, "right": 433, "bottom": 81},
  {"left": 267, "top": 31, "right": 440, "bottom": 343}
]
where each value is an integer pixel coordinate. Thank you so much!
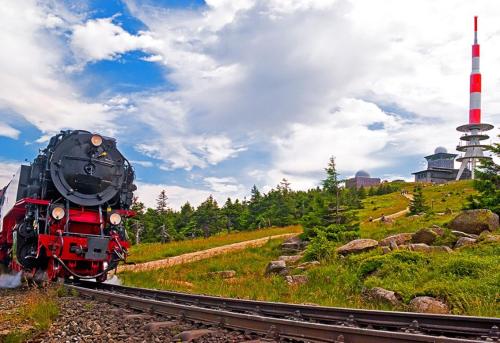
[{"left": 457, "top": 16, "right": 493, "bottom": 180}]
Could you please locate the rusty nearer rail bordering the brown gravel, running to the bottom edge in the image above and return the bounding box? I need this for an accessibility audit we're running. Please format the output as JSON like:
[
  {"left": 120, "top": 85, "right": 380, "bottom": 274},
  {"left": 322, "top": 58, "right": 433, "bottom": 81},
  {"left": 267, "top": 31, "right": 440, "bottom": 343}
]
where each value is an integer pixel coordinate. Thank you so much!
[{"left": 69, "top": 285, "right": 486, "bottom": 343}]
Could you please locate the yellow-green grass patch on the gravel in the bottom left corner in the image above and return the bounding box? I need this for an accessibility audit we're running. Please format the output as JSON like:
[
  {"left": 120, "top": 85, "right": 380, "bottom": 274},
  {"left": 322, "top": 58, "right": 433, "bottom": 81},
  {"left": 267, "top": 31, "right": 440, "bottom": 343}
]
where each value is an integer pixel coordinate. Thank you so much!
[{"left": 0, "top": 289, "right": 59, "bottom": 343}]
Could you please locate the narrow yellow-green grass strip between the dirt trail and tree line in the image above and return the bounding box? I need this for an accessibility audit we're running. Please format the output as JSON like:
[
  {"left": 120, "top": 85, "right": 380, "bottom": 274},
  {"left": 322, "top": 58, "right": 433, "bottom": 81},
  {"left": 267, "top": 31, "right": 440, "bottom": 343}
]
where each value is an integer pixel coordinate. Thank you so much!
[{"left": 128, "top": 226, "right": 302, "bottom": 263}]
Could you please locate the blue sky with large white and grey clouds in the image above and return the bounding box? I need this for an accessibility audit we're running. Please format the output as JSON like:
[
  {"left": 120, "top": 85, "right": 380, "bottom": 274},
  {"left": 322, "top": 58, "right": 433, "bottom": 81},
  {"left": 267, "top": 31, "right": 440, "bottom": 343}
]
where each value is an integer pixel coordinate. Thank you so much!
[{"left": 0, "top": 0, "right": 500, "bottom": 208}]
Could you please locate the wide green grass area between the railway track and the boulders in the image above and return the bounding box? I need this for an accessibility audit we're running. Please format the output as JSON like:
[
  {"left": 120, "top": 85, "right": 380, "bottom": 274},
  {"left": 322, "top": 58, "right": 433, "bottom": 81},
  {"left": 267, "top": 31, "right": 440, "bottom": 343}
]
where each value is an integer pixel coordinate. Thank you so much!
[{"left": 120, "top": 239, "right": 500, "bottom": 316}]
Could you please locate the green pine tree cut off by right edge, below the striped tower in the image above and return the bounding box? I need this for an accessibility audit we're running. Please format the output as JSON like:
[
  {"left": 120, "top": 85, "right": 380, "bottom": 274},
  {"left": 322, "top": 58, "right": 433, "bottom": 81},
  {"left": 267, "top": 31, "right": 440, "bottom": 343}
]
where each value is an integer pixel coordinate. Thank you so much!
[{"left": 467, "top": 140, "right": 500, "bottom": 215}]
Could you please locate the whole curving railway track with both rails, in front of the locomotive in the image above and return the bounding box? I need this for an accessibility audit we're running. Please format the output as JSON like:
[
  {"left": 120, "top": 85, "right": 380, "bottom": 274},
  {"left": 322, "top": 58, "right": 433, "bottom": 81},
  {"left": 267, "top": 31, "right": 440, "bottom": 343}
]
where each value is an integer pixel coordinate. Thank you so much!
[{"left": 69, "top": 282, "right": 500, "bottom": 343}]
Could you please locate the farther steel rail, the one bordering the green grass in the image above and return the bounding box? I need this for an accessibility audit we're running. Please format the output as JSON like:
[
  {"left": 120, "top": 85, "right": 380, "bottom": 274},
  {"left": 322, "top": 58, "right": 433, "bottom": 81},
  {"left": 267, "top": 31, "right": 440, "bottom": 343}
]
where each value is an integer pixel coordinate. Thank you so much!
[{"left": 68, "top": 281, "right": 500, "bottom": 339}]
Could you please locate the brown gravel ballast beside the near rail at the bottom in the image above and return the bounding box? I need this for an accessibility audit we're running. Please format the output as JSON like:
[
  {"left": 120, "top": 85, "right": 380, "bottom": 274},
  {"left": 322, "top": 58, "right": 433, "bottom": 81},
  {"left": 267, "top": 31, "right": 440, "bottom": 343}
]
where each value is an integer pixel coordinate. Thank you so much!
[{"left": 30, "top": 297, "right": 268, "bottom": 343}]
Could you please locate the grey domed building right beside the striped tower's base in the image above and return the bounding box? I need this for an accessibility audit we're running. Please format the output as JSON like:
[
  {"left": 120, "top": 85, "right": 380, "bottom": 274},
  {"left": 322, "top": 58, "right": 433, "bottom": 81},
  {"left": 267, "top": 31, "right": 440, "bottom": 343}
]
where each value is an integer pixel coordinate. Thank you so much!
[{"left": 413, "top": 146, "right": 471, "bottom": 183}]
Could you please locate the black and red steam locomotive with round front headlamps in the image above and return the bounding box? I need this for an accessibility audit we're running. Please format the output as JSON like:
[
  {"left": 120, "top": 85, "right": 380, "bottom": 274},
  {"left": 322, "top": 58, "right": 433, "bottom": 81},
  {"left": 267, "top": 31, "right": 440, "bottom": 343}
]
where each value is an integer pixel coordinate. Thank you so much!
[{"left": 0, "top": 130, "right": 136, "bottom": 282}]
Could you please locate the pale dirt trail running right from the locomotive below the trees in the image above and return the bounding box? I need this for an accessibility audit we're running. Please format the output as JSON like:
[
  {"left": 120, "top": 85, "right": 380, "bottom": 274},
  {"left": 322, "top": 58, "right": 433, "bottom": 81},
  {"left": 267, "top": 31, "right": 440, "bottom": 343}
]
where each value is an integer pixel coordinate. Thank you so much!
[{"left": 118, "top": 233, "right": 298, "bottom": 273}]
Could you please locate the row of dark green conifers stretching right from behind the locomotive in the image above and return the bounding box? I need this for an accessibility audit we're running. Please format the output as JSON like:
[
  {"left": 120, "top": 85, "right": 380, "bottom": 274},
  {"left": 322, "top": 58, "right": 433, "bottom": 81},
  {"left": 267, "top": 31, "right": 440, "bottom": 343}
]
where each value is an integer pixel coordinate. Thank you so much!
[{"left": 126, "top": 157, "right": 404, "bottom": 243}]
